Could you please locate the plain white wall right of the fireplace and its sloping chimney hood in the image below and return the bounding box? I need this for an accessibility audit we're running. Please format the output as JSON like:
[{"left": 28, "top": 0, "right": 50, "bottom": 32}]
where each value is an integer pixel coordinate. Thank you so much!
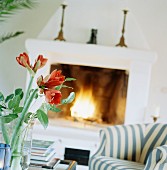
[{"left": 128, "top": 0, "right": 167, "bottom": 123}]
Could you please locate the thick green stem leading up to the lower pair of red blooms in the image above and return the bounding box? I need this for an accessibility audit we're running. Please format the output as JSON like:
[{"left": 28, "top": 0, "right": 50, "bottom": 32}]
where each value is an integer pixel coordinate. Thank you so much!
[{"left": 11, "top": 89, "right": 38, "bottom": 152}]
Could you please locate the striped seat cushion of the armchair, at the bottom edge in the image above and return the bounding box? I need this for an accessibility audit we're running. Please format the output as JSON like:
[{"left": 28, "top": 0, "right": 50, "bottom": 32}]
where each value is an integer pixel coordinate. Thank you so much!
[{"left": 89, "top": 156, "right": 145, "bottom": 170}]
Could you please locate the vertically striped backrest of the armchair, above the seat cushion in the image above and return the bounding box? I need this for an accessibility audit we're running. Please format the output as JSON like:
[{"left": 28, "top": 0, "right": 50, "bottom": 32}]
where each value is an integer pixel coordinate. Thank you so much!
[{"left": 101, "top": 124, "right": 145, "bottom": 162}]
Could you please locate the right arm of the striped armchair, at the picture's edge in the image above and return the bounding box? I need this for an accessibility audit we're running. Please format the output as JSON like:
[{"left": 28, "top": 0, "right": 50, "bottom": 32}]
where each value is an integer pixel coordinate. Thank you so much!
[{"left": 144, "top": 145, "right": 167, "bottom": 170}]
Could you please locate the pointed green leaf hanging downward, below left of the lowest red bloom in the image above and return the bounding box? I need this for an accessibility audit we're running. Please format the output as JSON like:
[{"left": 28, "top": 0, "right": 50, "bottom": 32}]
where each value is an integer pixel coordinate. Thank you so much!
[{"left": 37, "top": 109, "right": 48, "bottom": 129}]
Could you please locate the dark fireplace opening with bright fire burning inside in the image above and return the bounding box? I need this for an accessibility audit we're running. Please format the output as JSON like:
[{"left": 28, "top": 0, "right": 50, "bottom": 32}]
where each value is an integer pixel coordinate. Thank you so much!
[{"left": 49, "top": 64, "right": 128, "bottom": 125}]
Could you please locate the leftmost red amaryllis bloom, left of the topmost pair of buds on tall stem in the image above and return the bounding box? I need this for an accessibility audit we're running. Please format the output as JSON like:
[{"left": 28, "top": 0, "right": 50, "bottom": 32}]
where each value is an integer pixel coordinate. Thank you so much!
[{"left": 16, "top": 53, "right": 31, "bottom": 67}]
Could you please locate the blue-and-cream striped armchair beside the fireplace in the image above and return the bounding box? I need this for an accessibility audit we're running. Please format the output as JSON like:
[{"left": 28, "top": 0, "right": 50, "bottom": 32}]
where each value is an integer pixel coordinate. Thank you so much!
[{"left": 89, "top": 124, "right": 167, "bottom": 170}]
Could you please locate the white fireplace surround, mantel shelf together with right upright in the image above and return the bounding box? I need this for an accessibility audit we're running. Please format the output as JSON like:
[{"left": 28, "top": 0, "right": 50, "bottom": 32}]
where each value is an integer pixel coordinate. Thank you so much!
[{"left": 26, "top": 39, "right": 157, "bottom": 124}]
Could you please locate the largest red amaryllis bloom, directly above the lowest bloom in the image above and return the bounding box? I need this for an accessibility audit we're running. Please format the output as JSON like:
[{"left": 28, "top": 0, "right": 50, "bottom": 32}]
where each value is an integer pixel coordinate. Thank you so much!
[{"left": 37, "top": 70, "right": 65, "bottom": 89}]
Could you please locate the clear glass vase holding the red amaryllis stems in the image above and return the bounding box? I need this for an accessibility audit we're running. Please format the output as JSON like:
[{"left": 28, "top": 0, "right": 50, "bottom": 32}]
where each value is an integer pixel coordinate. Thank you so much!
[{"left": 2, "top": 118, "right": 34, "bottom": 170}]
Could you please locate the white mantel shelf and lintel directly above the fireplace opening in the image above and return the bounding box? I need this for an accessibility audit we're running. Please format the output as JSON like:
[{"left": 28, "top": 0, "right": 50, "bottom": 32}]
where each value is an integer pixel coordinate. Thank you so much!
[{"left": 26, "top": 39, "right": 156, "bottom": 69}]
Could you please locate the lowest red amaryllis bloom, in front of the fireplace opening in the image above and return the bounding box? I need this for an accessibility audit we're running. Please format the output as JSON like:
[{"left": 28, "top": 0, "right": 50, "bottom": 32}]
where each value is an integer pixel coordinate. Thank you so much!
[{"left": 44, "top": 89, "right": 62, "bottom": 105}]
